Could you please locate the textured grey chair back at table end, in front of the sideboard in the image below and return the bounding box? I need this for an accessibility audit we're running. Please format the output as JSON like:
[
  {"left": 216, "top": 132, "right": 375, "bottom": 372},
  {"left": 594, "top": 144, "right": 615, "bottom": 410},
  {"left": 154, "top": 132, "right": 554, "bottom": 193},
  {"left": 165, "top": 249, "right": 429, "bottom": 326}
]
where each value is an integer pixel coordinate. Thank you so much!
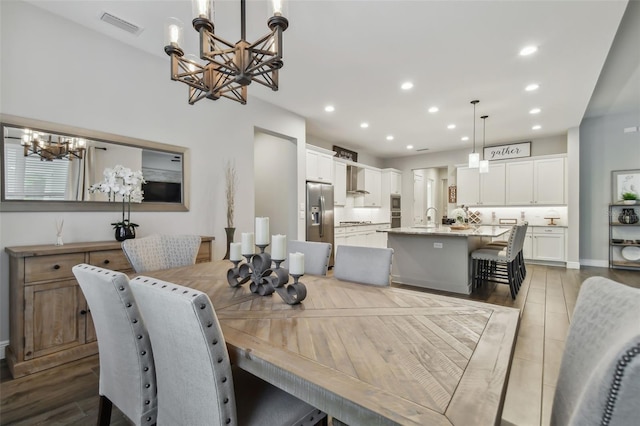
[{"left": 122, "top": 234, "right": 201, "bottom": 273}]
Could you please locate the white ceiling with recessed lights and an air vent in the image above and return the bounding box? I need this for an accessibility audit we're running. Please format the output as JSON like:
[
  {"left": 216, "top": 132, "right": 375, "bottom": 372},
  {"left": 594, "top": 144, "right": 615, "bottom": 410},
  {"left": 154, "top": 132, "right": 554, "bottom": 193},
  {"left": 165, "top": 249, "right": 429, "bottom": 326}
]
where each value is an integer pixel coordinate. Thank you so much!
[{"left": 22, "top": 0, "right": 627, "bottom": 158}]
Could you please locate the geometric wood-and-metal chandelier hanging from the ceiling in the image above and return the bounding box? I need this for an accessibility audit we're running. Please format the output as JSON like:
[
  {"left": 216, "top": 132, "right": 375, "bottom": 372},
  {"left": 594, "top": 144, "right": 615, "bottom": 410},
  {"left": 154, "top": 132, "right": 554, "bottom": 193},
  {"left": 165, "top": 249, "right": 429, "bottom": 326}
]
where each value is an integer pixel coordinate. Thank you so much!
[{"left": 164, "top": 0, "right": 289, "bottom": 105}]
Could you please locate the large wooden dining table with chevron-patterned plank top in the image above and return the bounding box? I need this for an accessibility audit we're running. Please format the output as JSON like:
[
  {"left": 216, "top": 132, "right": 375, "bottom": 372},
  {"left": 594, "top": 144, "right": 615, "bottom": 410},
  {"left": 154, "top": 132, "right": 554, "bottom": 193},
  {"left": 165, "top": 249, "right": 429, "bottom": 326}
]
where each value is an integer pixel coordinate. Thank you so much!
[{"left": 142, "top": 261, "right": 519, "bottom": 426}]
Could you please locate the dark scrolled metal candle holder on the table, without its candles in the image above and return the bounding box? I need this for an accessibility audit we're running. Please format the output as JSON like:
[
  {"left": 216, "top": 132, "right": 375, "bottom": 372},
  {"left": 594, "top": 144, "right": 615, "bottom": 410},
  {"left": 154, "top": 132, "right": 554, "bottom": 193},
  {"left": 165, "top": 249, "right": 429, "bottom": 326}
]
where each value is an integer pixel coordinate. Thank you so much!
[{"left": 227, "top": 245, "right": 307, "bottom": 305}]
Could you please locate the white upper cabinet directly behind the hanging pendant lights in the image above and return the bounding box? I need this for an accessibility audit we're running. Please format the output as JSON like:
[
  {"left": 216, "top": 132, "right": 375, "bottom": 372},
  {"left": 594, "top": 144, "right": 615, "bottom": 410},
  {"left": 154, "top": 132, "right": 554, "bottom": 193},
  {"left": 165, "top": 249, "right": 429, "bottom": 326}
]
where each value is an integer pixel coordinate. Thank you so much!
[{"left": 457, "top": 163, "right": 505, "bottom": 206}]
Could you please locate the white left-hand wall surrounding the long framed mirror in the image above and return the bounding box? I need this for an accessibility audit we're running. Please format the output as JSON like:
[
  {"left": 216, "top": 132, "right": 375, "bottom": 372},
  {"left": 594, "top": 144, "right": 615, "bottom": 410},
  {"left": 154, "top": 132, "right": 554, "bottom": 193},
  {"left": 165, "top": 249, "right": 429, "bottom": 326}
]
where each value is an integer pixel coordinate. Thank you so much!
[{"left": 0, "top": 1, "right": 305, "bottom": 342}]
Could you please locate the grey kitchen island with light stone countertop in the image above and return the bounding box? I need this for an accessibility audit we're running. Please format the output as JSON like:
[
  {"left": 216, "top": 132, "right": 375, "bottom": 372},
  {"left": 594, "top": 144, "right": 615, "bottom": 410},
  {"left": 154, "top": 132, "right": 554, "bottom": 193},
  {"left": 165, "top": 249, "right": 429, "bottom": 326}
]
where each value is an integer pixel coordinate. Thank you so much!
[{"left": 385, "top": 225, "right": 509, "bottom": 294}]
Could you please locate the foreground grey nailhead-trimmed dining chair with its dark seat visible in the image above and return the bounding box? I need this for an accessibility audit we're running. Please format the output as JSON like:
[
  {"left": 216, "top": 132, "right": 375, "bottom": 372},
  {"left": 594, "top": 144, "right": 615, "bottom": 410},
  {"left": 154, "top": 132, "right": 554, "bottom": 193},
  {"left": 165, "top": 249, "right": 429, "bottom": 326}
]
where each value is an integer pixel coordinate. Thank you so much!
[{"left": 131, "top": 276, "right": 326, "bottom": 426}]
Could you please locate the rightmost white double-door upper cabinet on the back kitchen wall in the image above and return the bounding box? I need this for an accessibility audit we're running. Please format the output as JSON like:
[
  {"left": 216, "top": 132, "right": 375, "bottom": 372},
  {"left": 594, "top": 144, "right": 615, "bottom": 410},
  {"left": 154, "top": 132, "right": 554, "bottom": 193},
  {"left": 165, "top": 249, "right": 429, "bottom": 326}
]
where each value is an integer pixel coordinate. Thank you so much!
[{"left": 506, "top": 157, "right": 565, "bottom": 206}]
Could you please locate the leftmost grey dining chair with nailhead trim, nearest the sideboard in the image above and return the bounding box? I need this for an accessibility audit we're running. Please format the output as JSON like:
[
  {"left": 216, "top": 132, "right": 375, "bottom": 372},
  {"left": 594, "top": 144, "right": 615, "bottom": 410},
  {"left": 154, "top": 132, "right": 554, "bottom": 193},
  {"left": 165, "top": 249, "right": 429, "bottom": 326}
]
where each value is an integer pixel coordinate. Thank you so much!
[{"left": 73, "top": 264, "right": 157, "bottom": 425}]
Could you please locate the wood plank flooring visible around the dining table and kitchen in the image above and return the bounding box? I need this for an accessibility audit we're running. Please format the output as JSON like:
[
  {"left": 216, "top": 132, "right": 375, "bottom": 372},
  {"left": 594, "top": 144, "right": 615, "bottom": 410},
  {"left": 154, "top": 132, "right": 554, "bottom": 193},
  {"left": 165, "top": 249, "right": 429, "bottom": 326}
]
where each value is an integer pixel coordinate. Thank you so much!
[{"left": 0, "top": 265, "right": 640, "bottom": 426}]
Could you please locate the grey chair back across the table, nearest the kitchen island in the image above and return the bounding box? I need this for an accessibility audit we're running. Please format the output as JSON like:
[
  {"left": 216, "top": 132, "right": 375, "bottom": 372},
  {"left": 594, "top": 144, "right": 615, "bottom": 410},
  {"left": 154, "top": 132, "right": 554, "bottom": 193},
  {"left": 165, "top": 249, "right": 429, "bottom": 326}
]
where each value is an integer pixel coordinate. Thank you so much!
[{"left": 333, "top": 245, "right": 393, "bottom": 286}]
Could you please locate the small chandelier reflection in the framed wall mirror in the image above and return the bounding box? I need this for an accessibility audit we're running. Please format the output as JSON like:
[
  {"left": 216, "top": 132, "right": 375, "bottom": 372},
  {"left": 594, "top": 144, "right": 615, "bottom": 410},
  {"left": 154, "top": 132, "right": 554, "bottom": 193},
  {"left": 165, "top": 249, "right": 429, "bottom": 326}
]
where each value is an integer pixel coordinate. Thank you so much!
[{"left": 22, "top": 130, "right": 86, "bottom": 161}]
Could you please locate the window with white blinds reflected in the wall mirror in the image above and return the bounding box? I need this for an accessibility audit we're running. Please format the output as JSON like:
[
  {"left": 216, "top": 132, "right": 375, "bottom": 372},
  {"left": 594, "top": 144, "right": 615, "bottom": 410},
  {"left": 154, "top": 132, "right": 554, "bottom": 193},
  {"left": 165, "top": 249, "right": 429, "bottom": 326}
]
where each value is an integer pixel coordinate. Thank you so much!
[{"left": 4, "top": 139, "right": 69, "bottom": 201}]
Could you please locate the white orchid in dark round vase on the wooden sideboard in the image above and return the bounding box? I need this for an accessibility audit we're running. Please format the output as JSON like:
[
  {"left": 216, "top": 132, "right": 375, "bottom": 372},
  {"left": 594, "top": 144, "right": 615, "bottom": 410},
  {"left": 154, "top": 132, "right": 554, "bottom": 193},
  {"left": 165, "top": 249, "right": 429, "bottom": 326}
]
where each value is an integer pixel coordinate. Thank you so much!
[{"left": 89, "top": 165, "right": 146, "bottom": 241}]
